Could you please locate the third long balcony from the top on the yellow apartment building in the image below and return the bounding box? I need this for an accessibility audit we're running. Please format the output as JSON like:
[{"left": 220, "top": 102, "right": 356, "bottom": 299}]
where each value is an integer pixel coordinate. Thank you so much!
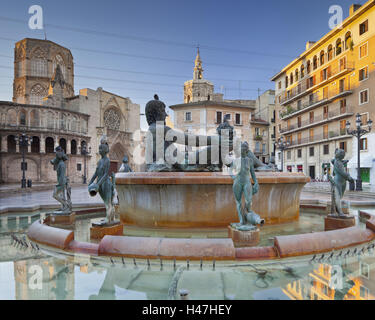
[{"left": 280, "top": 107, "right": 354, "bottom": 134}]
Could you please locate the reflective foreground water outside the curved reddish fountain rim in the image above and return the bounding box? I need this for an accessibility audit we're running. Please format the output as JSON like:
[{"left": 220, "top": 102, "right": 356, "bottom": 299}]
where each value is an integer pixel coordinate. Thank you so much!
[{"left": 0, "top": 210, "right": 375, "bottom": 300}]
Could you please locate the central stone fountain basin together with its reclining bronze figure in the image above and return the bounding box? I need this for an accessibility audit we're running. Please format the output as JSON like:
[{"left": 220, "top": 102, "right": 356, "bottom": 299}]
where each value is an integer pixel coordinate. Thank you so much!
[{"left": 116, "top": 96, "right": 309, "bottom": 229}]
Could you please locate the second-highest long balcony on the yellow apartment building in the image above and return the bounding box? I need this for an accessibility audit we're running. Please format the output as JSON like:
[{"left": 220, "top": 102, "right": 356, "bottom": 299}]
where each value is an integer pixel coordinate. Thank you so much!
[{"left": 280, "top": 84, "right": 352, "bottom": 120}]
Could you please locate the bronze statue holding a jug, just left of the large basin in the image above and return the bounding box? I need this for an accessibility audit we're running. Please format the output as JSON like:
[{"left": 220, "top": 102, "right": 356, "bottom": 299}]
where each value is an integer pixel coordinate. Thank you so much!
[{"left": 88, "top": 135, "right": 115, "bottom": 225}]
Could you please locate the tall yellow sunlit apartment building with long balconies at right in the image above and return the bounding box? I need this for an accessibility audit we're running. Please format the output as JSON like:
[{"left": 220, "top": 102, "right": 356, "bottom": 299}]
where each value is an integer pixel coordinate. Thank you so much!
[{"left": 272, "top": 0, "right": 375, "bottom": 183}]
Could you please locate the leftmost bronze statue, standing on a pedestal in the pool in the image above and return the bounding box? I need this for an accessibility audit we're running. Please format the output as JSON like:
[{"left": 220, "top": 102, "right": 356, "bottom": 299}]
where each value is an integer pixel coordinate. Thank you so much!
[{"left": 51, "top": 146, "right": 72, "bottom": 215}]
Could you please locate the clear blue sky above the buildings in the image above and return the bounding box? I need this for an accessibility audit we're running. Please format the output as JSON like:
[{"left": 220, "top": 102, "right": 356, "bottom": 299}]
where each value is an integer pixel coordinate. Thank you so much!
[{"left": 0, "top": 0, "right": 366, "bottom": 127}]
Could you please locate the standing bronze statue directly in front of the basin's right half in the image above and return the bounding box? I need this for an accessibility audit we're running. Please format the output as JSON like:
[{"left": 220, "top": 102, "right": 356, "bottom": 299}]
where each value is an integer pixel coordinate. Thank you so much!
[{"left": 230, "top": 142, "right": 264, "bottom": 231}]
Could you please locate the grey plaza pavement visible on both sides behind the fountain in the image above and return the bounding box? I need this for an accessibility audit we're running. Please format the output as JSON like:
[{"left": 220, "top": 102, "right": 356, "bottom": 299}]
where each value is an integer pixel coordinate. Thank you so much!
[{"left": 0, "top": 182, "right": 375, "bottom": 213}]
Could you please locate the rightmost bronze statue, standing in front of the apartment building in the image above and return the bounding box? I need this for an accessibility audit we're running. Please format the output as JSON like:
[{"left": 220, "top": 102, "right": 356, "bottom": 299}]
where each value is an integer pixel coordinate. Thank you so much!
[{"left": 328, "top": 149, "right": 354, "bottom": 218}]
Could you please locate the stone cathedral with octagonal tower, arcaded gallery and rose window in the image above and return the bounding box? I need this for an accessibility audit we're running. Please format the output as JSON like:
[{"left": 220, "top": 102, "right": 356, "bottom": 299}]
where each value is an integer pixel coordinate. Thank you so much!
[{"left": 0, "top": 38, "right": 141, "bottom": 183}]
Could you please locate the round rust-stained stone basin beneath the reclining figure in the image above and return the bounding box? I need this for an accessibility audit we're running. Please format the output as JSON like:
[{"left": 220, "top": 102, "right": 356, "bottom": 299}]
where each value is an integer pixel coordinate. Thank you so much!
[{"left": 116, "top": 172, "right": 310, "bottom": 228}]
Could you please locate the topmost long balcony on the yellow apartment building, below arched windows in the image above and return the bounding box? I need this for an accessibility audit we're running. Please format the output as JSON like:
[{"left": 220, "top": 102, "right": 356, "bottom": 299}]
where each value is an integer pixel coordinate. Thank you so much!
[{"left": 280, "top": 62, "right": 354, "bottom": 105}]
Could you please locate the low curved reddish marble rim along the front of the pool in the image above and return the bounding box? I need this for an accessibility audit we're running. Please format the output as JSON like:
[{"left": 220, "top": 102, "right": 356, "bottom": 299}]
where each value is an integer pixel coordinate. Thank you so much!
[{"left": 27, "top": 212, "right": 375, "bottom": 261}]
